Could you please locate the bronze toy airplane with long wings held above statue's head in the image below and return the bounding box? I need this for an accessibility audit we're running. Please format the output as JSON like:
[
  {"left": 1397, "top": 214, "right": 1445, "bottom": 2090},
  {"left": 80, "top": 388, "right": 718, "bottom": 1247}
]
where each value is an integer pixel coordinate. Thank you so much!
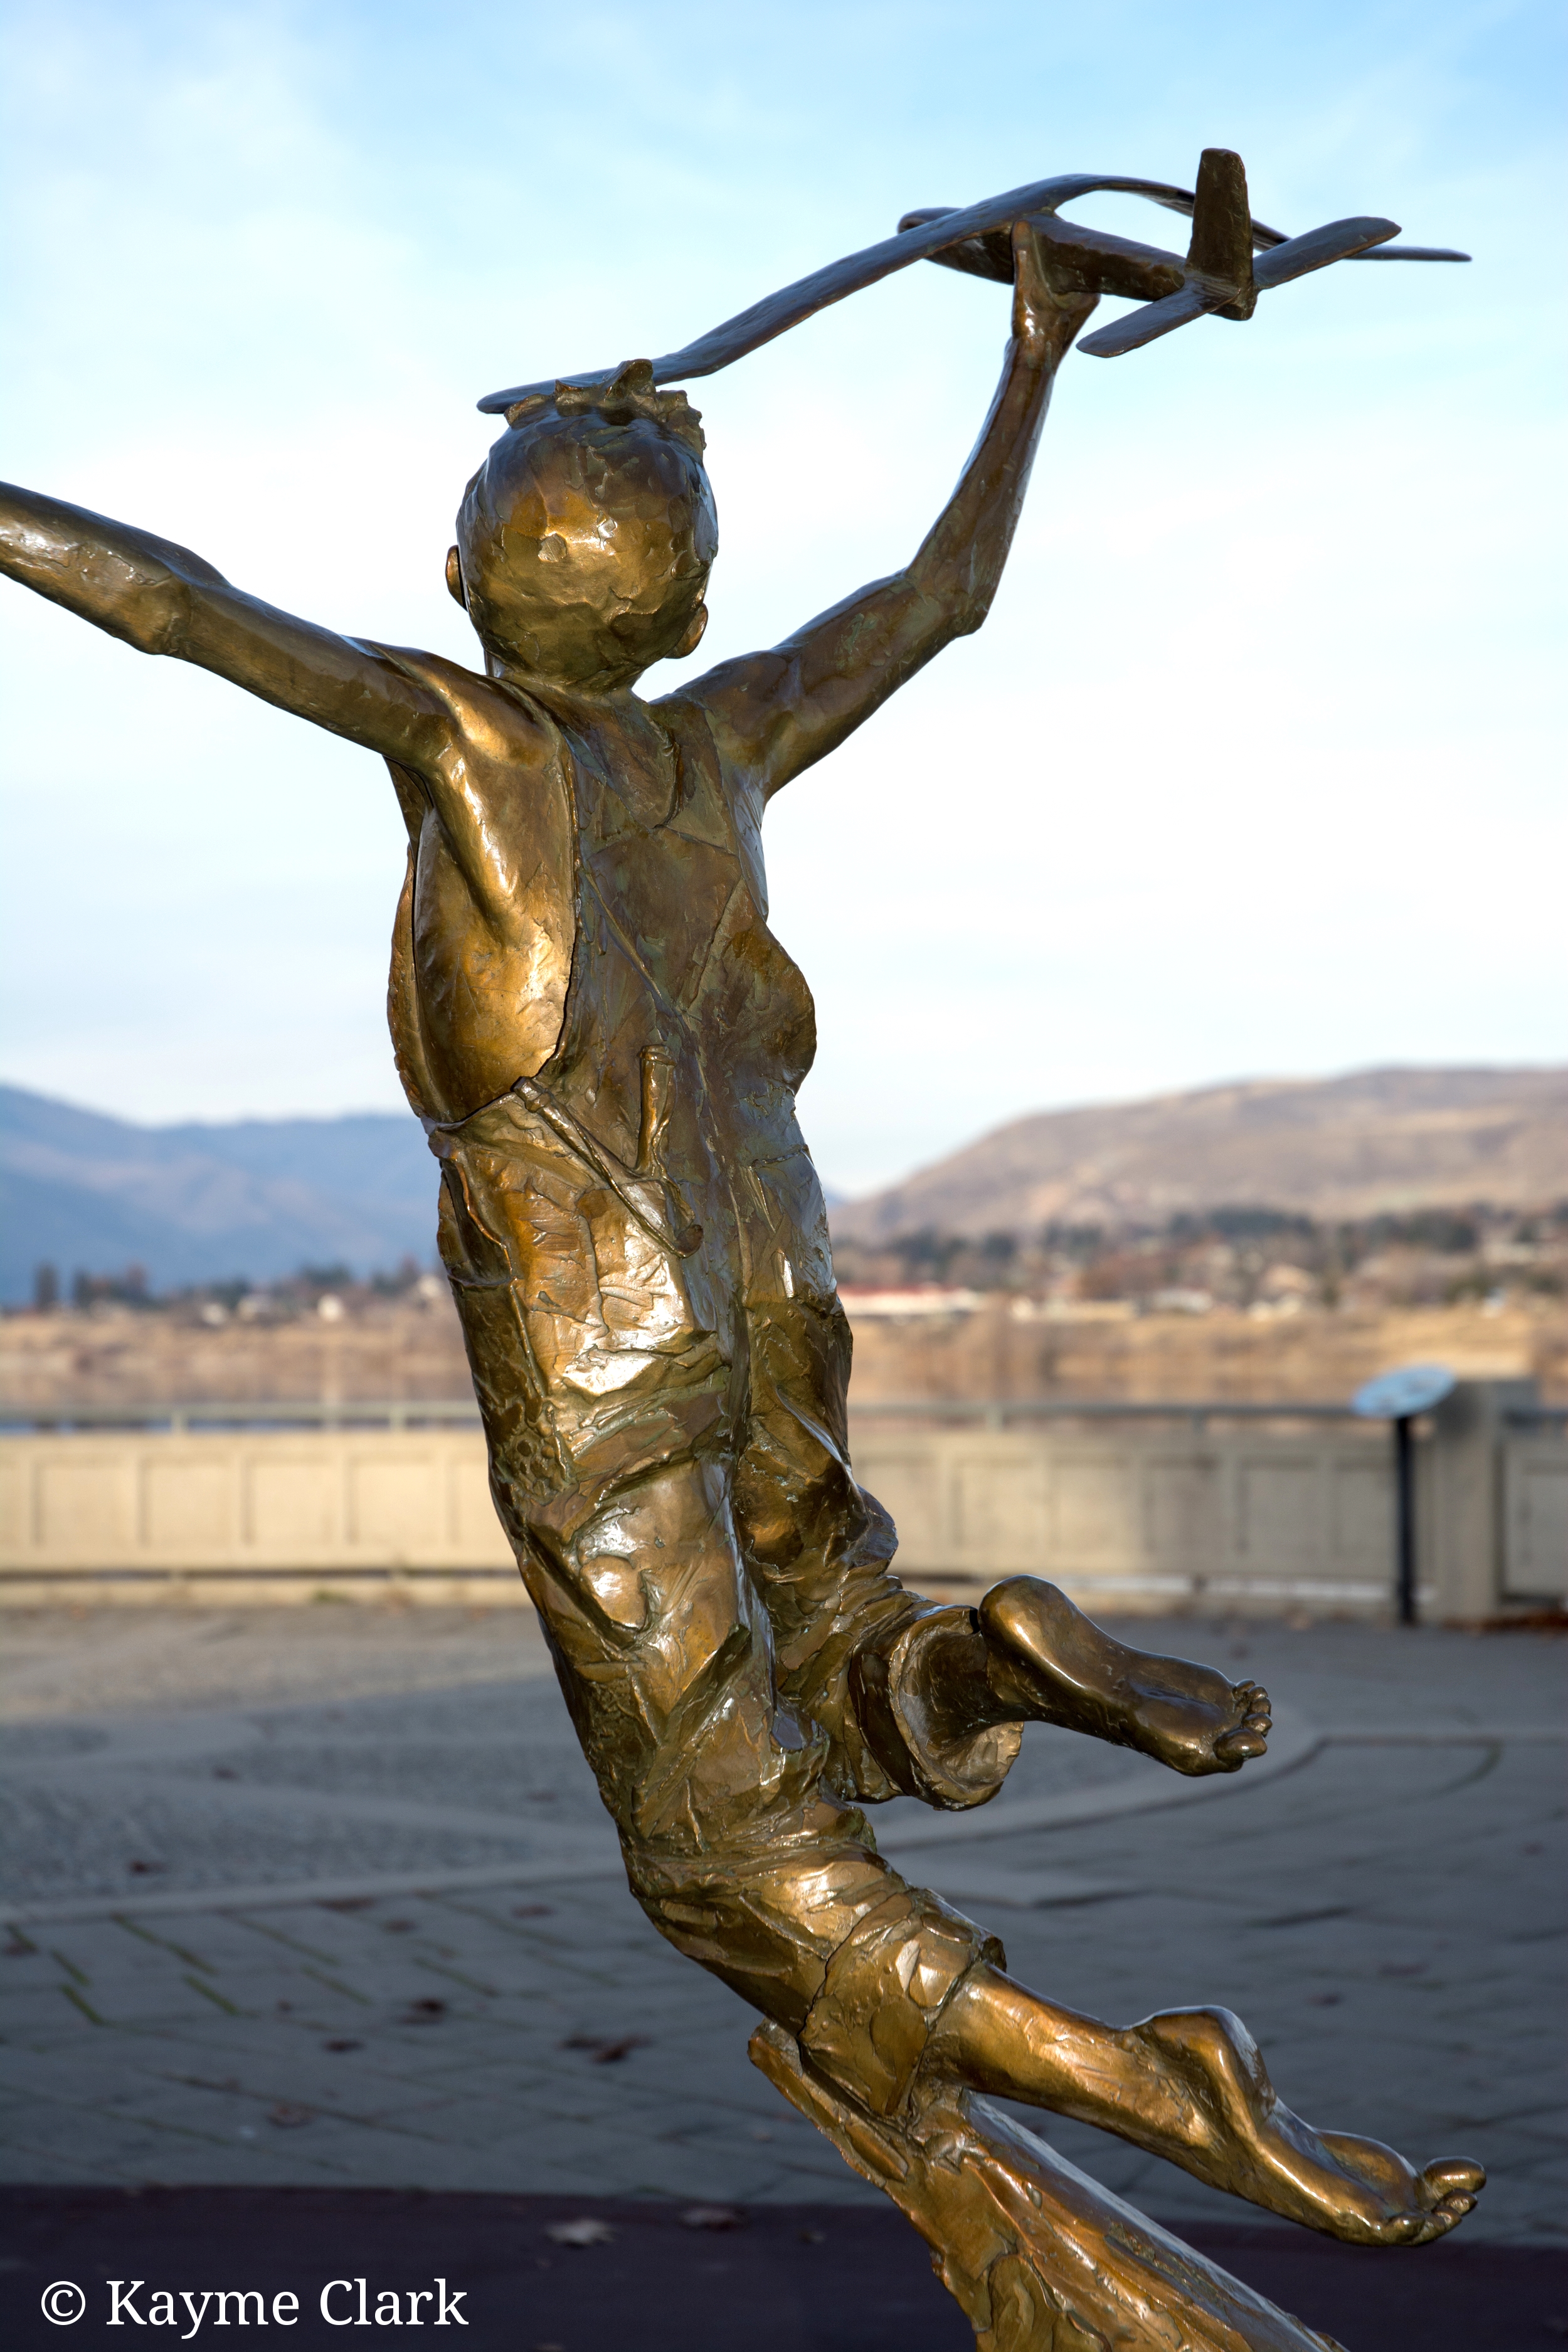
[{"left": 480, "top": 148, "right": 1470, "bottom": 416}]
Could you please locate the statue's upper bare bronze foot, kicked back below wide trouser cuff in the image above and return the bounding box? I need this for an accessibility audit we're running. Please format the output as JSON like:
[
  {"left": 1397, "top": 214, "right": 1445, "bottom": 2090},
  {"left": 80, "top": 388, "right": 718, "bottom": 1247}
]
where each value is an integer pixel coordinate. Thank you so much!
[{"left": 980, "top": 1576, "right": 1269, "bottom": 1776}]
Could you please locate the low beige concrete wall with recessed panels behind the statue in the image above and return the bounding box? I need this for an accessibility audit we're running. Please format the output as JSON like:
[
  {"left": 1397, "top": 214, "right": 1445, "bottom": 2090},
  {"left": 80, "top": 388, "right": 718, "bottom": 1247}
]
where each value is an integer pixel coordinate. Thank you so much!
[{"left": 0, "top": 1383, "right": 1568, "bottom": 1618}]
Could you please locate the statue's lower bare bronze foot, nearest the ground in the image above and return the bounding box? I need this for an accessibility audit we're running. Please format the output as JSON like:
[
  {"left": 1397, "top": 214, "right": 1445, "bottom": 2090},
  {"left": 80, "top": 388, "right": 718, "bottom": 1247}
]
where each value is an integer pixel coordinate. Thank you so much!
[{"left": 1124, "top": 2009, "right": 1486, "bottom": 2246}]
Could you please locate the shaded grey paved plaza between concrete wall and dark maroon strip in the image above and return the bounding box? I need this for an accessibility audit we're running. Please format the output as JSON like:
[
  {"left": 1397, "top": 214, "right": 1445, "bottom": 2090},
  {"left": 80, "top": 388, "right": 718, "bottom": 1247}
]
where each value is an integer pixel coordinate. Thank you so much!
[{"left": 0, "top": 1609, "right": 1568, "bottom": 2244}]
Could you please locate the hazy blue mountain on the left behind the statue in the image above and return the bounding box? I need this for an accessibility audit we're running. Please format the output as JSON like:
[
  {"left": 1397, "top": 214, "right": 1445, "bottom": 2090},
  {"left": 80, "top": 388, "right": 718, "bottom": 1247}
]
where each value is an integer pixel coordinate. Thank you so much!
[{"left": 0, "top": 1087, "right": 437, "bottom": 1303}]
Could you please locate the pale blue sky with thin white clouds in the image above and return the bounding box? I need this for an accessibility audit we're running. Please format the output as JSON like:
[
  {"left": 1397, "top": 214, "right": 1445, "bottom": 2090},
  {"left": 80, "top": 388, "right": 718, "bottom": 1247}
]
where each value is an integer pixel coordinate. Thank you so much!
[{"left": 0, "top": 0, "right": 1568, "bottom": 1190}]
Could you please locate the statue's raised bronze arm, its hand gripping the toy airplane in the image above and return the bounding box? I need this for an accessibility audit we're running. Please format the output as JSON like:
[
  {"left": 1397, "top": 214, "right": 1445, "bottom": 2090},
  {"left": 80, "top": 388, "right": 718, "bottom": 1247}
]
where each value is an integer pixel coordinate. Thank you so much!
[{"left": 679, "top": 221, "right": 1093, "bottom": 795}]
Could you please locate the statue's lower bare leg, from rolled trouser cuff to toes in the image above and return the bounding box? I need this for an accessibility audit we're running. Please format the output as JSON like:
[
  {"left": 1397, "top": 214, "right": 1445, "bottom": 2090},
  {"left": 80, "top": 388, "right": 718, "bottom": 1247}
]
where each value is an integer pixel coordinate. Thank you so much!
[{"left": 926, "top": 1962, "right": 1486, "bottom": 2246}]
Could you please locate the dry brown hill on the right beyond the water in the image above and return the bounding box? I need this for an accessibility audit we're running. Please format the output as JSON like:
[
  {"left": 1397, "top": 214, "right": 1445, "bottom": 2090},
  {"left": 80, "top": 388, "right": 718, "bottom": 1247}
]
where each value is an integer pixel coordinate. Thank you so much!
[{"left": 832, "top": 1068, "right": 1568, "bottom": 1242}]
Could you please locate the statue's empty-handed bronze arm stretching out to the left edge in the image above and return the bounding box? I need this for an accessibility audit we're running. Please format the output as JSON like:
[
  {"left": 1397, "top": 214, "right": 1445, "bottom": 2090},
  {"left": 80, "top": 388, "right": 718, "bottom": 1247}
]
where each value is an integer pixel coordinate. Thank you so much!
[{"left": 0, "top": 485, "right": 449, "bottom": 769}]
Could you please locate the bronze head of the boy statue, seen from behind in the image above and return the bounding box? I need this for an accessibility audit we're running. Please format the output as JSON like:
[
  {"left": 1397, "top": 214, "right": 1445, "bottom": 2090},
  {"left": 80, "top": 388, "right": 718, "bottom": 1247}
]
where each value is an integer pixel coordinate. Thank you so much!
[{"left": 447, "top": 360, "right": 719, "bottom": 694}]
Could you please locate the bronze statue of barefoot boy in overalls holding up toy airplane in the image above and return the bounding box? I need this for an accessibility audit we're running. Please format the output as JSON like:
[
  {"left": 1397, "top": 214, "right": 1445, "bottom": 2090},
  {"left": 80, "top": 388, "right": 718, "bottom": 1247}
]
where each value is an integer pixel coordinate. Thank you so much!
[{"left": 0, "top": 157, "right": 1483, "bottom": 2352}]
